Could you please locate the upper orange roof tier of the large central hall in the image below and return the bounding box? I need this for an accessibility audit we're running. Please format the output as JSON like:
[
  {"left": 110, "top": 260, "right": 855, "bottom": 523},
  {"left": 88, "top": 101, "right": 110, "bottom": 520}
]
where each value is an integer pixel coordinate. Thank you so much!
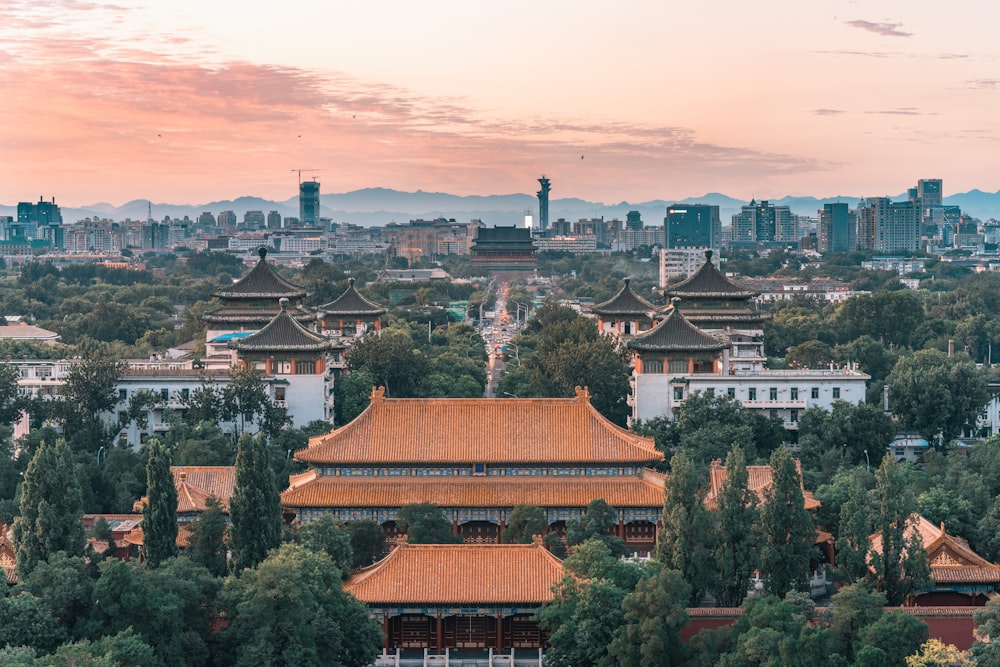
[{"left": 295, "top": 388, "right": 663, "bottom": 465}]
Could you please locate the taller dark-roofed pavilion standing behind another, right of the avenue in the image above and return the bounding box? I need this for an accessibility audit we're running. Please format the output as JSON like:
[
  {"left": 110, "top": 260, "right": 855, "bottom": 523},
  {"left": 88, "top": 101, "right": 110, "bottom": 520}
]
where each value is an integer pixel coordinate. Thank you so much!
[{"left": 663, "top": 250, "right": 771, "bottom": 370}]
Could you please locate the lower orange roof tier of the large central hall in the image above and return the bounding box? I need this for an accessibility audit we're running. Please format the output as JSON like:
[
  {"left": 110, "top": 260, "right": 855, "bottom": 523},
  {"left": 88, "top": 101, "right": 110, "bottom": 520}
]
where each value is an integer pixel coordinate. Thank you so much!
[{"left": 281, "top": 470, "right": 663, "bottom": 508}]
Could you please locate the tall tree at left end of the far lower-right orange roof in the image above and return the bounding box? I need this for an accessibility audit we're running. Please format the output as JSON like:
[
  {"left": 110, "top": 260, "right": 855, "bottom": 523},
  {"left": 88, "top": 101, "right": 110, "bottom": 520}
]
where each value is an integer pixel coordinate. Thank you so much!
[{"left": 870, "top": 454, "right": 930, "bottom": 606}]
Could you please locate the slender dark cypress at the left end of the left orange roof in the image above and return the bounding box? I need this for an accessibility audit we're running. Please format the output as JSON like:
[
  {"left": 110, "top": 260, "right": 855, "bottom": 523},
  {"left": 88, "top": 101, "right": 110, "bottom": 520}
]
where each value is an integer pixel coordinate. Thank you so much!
[{"left": 142, "top": 438, "right": 177, "bottom": 567}]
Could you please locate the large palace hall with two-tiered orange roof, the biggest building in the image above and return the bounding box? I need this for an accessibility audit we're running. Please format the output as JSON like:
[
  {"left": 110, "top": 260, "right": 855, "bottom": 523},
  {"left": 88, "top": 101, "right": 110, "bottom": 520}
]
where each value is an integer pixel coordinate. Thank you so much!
[{"left": 281, "top": 389, "right": 663, "bottom": 553}]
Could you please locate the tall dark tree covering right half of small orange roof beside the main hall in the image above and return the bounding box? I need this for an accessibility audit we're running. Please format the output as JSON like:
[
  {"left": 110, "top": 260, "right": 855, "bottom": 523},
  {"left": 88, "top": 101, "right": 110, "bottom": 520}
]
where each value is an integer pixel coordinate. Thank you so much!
[{"left": 760, "top": 447, "right": 816, "bottom": 594}]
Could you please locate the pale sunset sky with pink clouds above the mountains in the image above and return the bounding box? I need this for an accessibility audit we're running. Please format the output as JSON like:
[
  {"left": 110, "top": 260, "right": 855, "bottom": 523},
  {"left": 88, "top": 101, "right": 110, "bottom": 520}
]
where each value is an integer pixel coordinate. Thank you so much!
[{"left": 0, "top": 0, "right": 1000, "bottom": 206}]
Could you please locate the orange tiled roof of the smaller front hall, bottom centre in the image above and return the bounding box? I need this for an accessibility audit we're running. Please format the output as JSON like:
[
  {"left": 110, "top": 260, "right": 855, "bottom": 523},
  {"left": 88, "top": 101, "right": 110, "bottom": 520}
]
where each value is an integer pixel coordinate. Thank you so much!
[{"left": 344, "top": 543, "right": 563, "bottom": 605}]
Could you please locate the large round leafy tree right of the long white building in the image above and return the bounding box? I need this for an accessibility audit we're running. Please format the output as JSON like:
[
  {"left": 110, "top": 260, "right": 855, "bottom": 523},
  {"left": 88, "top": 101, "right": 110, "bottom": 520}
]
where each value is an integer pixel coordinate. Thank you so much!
[{"left": 886, "top": 350, "right": 990, "bottom": 443}]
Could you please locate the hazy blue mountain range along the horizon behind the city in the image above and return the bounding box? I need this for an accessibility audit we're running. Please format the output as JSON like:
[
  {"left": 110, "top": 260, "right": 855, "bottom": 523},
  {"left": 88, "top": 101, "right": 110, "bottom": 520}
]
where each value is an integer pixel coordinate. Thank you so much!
[{"left": 0, "top": 188, "right": 1000, "bottom": 227}]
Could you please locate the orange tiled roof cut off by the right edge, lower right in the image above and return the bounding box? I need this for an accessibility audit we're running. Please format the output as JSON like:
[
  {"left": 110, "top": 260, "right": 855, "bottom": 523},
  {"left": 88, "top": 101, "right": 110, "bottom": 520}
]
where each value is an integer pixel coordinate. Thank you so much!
[{"left": 868, "top": 514, "right": 1000, "bottom": 584}]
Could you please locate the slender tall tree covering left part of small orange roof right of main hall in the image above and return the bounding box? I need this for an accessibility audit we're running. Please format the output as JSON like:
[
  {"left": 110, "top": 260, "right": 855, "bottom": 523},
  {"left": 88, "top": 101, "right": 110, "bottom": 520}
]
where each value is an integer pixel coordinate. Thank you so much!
[{"left": 714, "top": 445, "right": 759, "bottom": 607}]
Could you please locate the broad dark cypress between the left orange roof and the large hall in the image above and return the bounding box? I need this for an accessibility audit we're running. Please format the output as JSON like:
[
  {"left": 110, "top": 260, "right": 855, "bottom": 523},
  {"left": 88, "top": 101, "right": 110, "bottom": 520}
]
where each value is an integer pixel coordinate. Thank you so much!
[{"left": 229, "top": 435, "right": 281, "bottom": 573}]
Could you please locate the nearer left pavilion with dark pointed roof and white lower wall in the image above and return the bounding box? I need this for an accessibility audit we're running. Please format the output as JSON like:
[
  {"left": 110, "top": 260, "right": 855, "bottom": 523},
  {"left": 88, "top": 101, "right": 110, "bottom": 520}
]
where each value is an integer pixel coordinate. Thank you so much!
[{"left": 229, "top": 300, "right": 334, "bottom": 426}]
